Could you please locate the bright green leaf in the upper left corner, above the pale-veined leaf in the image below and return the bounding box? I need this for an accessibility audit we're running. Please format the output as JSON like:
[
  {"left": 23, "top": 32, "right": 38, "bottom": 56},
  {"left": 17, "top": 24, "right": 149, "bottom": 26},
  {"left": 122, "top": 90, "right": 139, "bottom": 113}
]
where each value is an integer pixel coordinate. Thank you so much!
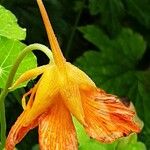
[{"left": 0, "top": 5, "right": 26, "bottom": 40}]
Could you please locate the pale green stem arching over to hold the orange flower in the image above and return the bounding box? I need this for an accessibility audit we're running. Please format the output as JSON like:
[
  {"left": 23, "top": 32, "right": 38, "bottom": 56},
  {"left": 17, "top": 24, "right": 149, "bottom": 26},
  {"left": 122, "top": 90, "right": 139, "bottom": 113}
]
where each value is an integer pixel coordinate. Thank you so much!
[{"left": 0, "top": 43, "right": 54, "bottom": 149}]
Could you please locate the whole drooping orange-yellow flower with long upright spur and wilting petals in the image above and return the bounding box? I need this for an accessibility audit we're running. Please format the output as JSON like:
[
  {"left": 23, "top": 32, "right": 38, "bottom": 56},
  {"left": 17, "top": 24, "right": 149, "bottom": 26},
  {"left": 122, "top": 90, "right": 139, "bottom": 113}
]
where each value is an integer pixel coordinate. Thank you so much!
[{"left": 5, "top": 0, "right": 140, "bottom": 150}]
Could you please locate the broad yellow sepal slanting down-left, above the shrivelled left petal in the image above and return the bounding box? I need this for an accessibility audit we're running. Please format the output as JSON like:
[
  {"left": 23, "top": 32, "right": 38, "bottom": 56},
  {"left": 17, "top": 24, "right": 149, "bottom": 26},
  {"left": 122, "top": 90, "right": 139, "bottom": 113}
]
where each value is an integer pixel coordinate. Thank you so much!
[{"left": 23, "top": 66, "right": 59, "bottom": 125}]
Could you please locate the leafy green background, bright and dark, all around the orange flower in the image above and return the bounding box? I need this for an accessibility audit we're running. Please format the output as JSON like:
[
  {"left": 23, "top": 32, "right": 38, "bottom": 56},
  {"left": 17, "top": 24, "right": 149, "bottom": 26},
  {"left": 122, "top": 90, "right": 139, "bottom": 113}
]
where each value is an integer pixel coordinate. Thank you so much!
[{"left": 0, "top": 0, "right": 150, "bottom": 150}]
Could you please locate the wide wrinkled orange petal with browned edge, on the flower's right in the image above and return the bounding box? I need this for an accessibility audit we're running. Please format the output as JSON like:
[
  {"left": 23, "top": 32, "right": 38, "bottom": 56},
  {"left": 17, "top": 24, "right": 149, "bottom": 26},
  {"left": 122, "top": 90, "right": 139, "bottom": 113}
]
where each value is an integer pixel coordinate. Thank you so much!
[{"left": 82, "top": 90, "right": 140, "bottom": 142}]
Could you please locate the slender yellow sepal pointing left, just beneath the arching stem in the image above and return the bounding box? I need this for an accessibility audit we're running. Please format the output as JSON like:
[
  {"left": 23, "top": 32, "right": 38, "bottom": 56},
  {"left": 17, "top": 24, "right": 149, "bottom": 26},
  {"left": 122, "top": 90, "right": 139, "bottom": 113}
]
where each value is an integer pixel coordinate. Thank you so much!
[{"left": 9, "top": 65, "right": 49, "bottom": 90}]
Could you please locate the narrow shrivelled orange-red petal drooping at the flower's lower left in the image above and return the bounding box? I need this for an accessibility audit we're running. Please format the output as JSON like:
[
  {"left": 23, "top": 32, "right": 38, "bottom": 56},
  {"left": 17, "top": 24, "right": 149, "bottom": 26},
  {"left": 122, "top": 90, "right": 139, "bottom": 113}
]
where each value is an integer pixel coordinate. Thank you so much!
[{"left": 5, "top": 106, "right": 38, "bottom": 150}]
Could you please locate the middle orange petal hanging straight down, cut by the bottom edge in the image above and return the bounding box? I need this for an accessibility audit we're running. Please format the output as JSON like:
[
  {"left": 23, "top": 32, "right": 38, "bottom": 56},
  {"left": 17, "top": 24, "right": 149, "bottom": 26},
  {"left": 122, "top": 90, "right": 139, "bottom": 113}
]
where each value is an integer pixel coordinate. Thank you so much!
[{"left": 39, "top": 99, "right": 78, "bottom": 150}]
